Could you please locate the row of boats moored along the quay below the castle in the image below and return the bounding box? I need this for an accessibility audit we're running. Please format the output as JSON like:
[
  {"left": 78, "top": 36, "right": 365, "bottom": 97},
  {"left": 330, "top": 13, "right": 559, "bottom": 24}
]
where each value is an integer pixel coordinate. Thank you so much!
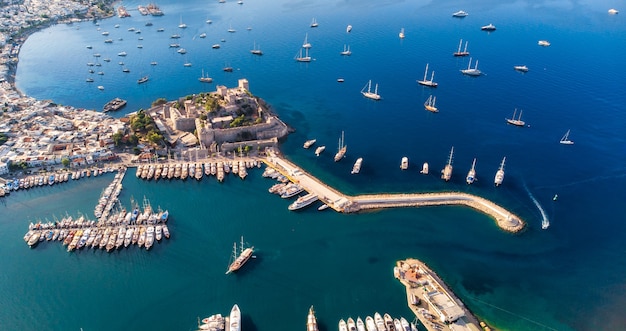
[{"left": 136, "top": 160, "right": 261, "bottom": 182}]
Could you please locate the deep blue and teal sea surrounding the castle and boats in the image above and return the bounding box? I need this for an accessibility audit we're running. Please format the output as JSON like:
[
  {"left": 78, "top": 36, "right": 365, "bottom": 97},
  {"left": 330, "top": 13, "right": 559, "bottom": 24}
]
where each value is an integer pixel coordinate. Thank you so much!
[{"left": 0, "top": 0, "right": 626, "bottom": 331}]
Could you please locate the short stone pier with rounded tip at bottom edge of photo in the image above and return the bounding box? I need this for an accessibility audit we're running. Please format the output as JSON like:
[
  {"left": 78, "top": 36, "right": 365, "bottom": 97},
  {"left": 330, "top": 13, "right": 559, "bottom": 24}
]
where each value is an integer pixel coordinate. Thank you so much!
[{"left": 393, "top": 259, "right": 490, "bottom": 331}]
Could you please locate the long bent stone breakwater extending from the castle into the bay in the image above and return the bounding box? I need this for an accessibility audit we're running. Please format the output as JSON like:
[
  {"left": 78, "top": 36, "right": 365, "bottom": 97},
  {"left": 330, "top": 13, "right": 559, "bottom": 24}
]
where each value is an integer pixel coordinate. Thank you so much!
[{"left": 263, "top": 151, "right": 525, "bottom": 233}]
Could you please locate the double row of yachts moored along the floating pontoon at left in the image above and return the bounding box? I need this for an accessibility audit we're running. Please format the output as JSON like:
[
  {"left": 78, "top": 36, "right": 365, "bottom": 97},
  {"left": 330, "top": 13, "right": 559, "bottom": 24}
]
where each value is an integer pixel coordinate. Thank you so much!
[{"left": 24, "top": 204, "right": 170, "bottom": 252}]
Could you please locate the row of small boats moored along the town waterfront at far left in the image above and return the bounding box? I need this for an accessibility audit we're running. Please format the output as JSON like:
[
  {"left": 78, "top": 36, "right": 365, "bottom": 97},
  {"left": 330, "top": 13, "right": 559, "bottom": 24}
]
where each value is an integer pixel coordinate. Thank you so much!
[{"left": 0, "top": 167, "right": 120, "bottom": 194}]
